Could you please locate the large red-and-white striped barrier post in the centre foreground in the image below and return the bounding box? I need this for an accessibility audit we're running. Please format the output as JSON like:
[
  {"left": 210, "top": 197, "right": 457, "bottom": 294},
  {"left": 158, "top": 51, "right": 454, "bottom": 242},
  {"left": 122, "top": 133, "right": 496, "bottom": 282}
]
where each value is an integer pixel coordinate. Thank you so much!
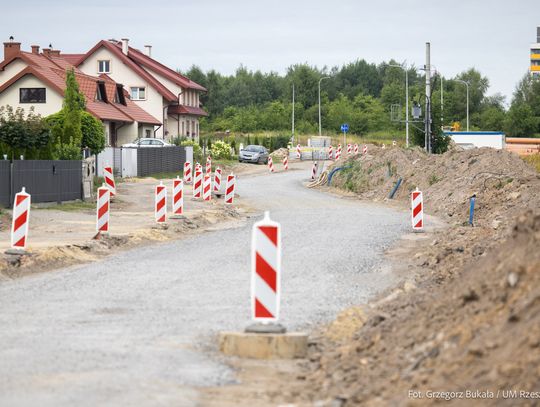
[{"left": 251, "top": 212, "right": 281, "bottom": 322}]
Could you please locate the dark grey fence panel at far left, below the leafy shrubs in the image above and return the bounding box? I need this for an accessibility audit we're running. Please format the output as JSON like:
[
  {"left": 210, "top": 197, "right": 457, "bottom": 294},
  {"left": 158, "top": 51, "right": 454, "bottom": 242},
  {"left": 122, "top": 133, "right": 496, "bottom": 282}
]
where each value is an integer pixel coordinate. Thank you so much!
[{"left": 12, "top": 160, "right": 82, "bottom": 203}]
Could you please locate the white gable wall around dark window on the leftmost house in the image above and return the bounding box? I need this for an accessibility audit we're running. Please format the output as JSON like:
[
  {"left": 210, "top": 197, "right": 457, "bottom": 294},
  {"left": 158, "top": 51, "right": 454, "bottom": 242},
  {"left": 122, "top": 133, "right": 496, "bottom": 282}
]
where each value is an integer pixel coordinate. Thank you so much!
[{"left": 0, "top": 75, "right": 64, "bottom": 117}]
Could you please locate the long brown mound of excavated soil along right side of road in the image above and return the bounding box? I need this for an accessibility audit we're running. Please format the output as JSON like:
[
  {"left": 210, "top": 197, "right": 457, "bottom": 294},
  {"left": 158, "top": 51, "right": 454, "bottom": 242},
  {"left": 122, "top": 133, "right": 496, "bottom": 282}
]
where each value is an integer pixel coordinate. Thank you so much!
[{"left": 286, "top": 146, "right": 540, "bottom": 406}]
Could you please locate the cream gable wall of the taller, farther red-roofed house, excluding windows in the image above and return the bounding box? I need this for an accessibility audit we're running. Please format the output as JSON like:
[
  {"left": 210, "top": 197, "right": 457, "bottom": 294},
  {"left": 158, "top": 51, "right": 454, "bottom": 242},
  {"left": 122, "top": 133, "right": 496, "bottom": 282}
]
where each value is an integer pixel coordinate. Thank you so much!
[{"left": 79, "top": 47, "right": 163, "bottom": 138}]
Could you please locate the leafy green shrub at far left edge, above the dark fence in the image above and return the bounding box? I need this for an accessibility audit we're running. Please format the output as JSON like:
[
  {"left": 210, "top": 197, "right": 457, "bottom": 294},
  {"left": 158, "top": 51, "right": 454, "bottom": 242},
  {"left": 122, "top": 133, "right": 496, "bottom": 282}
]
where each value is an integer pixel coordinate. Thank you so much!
[{"left": 0, "top": 106, "right": 51, "bottom": 159}]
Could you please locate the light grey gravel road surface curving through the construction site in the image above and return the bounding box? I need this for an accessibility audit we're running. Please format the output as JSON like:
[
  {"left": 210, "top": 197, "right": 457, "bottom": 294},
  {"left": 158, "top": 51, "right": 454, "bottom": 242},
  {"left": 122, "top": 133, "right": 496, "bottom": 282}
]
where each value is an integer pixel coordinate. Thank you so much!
[{"left": 0, "top": 164, "right": 409, "bottom": 406}]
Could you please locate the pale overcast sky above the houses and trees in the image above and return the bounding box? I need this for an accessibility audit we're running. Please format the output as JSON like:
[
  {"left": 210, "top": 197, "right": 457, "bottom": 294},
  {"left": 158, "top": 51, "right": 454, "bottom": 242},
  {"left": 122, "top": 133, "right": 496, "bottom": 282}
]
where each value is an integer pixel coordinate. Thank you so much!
[{"left": 0, "top": 0, "right": 540, "bottom": 101}]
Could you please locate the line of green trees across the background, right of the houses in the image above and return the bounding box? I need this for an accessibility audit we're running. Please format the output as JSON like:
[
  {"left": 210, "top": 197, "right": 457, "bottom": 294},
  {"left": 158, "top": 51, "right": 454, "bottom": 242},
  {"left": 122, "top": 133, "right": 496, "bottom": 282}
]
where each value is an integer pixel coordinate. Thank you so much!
[{"left": 184, "top": 59, "right": 540, "bottom": 140}]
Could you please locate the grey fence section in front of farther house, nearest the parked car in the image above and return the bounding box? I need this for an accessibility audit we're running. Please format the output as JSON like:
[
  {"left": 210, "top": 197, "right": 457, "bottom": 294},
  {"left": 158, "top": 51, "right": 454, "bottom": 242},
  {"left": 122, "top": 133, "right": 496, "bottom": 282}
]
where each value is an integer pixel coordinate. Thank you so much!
[{"left": 137, "top": 147, "right": 186, "bottom": 177}]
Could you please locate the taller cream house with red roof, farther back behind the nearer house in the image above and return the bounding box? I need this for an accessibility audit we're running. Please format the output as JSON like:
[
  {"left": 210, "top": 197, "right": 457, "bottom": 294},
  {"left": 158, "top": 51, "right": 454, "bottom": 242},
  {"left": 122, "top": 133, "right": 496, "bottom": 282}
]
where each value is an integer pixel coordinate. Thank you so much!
[{"left": 76, "top": 38, "right": 207, "bottom": 141}]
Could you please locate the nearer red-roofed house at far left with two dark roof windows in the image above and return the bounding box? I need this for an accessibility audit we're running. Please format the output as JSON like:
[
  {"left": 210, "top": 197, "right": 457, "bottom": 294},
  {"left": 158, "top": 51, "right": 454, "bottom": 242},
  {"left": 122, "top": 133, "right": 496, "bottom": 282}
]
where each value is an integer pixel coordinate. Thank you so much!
[{"left": 0, "top": 41, "right": 162, "bottom": 146}]
